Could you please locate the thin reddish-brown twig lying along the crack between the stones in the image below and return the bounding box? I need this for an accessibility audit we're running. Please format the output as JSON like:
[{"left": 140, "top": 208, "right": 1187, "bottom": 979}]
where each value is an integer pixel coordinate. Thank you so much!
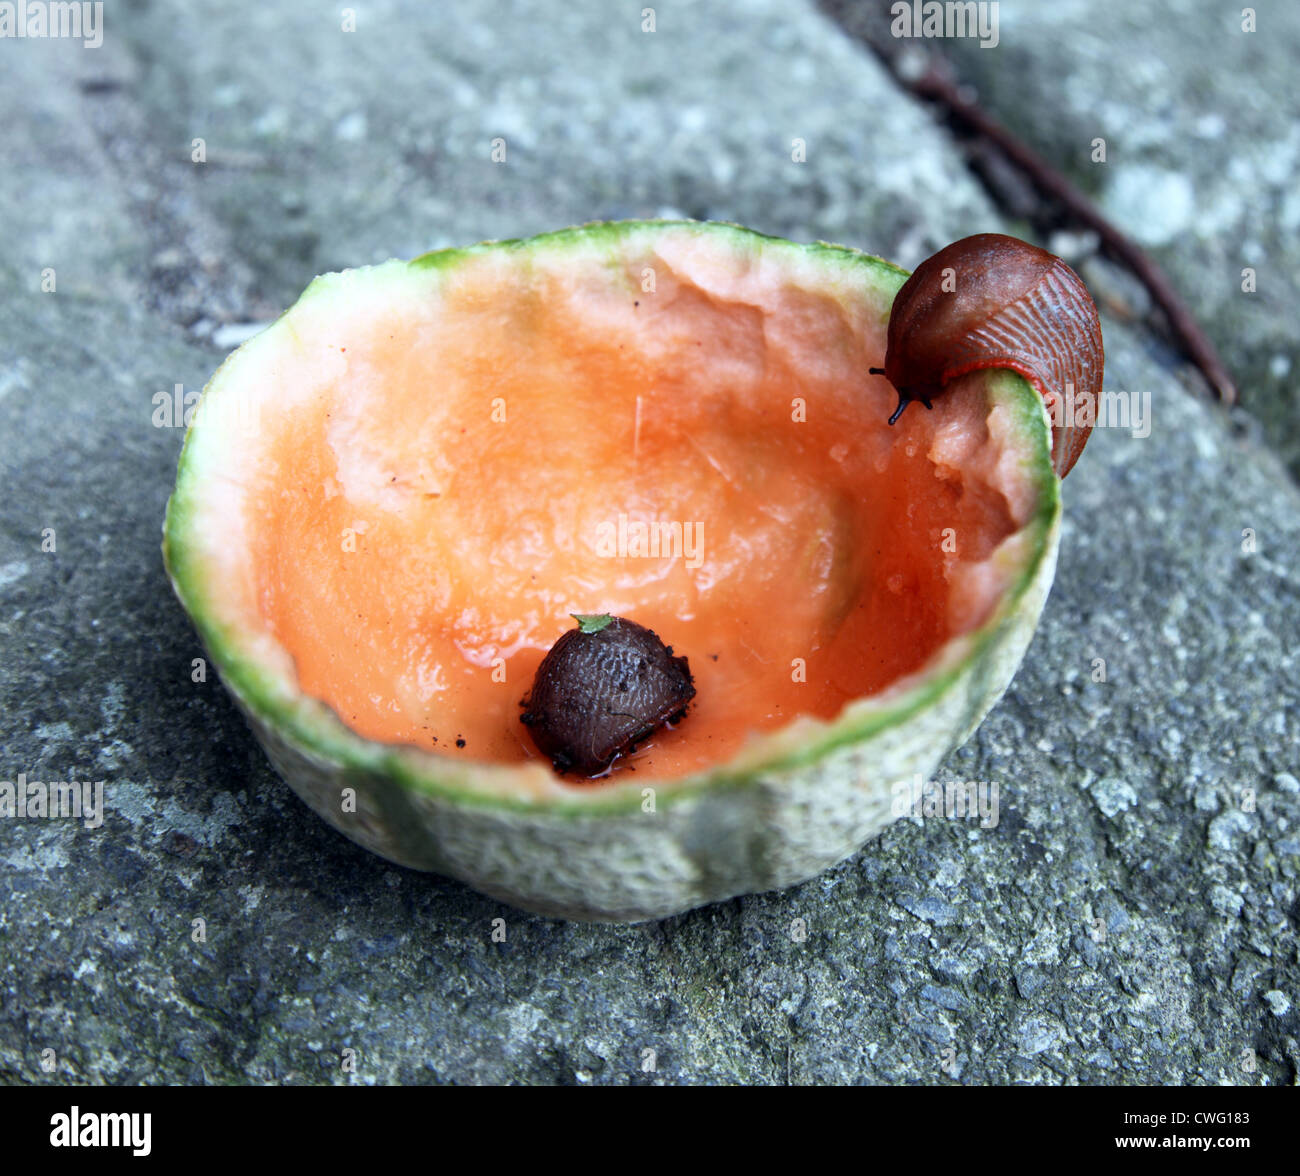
[{"left": 898, "top": 64, "right": 1236, "bottom": 404}]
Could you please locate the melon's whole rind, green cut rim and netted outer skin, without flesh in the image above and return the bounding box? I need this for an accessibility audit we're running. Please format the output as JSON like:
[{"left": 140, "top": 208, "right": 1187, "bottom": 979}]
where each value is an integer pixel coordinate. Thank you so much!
[{"left": 163, "top": 222, "right": 1061, "bottom": 921}]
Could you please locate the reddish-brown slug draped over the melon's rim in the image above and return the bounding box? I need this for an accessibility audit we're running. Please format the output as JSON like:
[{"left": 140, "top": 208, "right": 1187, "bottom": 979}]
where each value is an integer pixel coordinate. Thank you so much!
[{"left": 871, "top": 233, "right": 1104, "bottom": 478}]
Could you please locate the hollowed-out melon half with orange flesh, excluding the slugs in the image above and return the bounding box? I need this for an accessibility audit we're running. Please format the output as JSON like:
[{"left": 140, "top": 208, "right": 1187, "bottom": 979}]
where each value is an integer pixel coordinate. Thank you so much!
[{"left": 164, "top": 221, "right": 1060, "bottom": 920}]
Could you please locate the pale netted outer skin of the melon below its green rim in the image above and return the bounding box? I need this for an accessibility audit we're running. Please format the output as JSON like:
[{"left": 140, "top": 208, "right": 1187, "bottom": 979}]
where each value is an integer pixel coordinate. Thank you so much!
[{"left": 231, "top": 527, "right": 1060, "bottom": 923}]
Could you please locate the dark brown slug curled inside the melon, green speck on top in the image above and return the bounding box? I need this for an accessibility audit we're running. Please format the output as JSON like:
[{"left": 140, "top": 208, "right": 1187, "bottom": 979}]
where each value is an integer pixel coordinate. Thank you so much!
[{"left": 520, "top": 615, "right": 696, "bottom": 777}]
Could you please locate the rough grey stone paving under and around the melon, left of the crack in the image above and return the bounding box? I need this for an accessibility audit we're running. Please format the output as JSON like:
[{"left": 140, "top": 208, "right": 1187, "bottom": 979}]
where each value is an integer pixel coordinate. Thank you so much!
[{"left": 0, "top": 0, "right": 1300, "bottom": 1085}]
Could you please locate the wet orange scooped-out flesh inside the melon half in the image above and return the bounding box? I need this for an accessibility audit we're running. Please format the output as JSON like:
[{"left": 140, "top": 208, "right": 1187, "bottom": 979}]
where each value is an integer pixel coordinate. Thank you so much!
[{"left": 231, "top": 232, "right": 1034, "bottom": 777}]
